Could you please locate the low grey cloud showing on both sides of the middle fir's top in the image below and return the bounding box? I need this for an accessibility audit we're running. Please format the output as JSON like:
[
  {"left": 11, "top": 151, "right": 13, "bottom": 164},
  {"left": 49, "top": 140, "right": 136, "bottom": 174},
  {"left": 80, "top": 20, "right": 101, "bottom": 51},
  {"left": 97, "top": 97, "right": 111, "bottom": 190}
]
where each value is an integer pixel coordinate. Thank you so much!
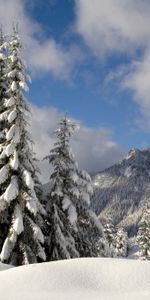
[{"left": 31, "top": 106, "right": 122, "bottom": 182}]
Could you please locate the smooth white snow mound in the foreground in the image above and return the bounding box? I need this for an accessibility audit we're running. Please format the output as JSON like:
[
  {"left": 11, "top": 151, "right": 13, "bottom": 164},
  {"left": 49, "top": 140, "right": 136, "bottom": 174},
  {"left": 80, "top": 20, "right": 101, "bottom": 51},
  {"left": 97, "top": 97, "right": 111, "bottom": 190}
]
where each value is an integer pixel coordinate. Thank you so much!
[{"left": 0, "top": 258, "right": 150, "bottom": 300}]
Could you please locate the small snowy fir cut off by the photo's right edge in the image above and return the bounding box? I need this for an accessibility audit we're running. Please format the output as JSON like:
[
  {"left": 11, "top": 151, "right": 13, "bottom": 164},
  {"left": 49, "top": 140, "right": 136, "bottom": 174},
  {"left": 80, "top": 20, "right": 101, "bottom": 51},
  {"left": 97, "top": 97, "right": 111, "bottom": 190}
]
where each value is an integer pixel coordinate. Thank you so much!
[{"left": 137, "top": 208, "right": 150, "bottom": 260}]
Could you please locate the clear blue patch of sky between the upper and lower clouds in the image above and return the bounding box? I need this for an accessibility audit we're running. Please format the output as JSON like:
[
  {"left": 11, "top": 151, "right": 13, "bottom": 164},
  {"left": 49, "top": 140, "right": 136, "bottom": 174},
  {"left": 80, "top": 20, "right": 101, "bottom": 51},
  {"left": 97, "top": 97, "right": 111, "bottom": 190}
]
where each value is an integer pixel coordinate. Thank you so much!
[{"left": 27, "top": 0, "right": 149, "bottom": 151}]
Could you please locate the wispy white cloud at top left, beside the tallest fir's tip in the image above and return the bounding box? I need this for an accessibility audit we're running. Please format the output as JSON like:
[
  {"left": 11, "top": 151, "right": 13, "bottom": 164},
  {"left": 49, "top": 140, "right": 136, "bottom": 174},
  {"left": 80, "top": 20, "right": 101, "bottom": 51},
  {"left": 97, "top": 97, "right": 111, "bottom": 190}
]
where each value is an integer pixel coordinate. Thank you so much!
[{"left": 0, "top": 0, "right": 80, "bottom": 80}]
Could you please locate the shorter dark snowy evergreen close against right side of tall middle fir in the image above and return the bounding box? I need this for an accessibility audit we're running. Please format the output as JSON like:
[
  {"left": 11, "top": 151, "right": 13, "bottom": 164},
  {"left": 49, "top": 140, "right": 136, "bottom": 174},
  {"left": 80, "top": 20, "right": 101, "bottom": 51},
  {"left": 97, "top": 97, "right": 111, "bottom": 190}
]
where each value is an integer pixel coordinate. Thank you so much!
[{"left": 72, "top": 170, "right": 106, "bottom": 257}]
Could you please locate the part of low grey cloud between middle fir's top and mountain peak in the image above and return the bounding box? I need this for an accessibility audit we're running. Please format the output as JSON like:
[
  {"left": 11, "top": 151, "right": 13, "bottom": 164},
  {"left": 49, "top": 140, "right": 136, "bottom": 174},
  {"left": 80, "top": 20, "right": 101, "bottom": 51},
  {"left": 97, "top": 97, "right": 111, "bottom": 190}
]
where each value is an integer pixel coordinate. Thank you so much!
[{"left": 72, "top": 125, "right": 122, "bottom": 173}]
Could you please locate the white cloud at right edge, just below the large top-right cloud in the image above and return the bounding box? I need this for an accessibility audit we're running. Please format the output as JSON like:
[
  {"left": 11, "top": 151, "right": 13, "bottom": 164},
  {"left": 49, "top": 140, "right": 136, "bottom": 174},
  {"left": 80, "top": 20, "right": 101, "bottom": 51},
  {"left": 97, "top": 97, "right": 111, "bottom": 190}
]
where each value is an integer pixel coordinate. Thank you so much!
[{"left": 104, "top": 48, "right": 150, "bottom": 127}]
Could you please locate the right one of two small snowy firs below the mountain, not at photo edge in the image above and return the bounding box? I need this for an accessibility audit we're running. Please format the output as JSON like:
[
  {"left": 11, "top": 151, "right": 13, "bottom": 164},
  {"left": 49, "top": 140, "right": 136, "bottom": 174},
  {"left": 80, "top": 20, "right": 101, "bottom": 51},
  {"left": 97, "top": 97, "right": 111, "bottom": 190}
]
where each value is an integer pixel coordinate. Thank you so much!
[{"left": 114, "top": 228, "right": 128, "bottom": 257}]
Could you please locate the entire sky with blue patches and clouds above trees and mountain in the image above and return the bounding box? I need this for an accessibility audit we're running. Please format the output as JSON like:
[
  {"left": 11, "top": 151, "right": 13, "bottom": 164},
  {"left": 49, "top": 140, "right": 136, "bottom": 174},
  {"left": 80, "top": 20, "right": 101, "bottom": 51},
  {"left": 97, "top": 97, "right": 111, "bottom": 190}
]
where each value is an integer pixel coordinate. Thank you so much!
[{"left": 0, "top": 0, "right": 150, "bottom": 180}]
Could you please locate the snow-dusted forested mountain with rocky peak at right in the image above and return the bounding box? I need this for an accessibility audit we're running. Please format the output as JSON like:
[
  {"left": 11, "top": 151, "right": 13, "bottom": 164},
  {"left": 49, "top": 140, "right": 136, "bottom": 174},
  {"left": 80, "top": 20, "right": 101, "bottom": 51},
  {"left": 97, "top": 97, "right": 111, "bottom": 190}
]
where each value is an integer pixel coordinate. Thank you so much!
[{"left": 91, "top": 149, "right": 150, "bottom": 236}]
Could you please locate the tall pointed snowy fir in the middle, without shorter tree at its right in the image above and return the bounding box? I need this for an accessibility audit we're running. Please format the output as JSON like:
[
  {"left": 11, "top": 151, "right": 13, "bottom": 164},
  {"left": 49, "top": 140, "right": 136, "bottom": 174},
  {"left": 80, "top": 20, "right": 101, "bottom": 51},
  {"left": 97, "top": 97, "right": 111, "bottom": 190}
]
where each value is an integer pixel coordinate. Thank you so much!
[{"left": 47, "top": 119, "right": 79, "bottom": 260}]
